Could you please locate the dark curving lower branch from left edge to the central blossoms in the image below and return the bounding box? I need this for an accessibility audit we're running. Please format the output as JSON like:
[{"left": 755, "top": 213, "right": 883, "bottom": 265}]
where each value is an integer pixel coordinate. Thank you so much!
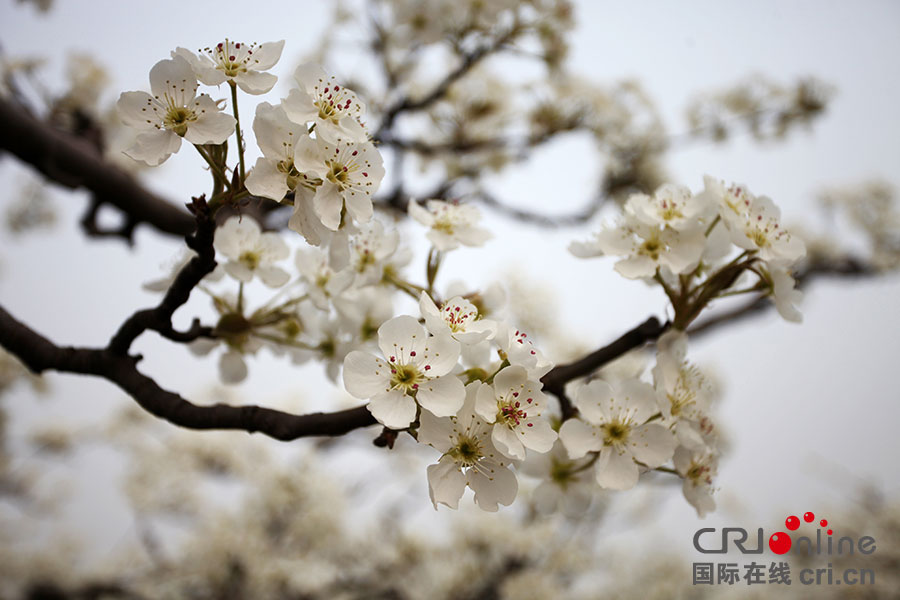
[{"left": 0, "top": 307, "right": 376, "bottom": 441}]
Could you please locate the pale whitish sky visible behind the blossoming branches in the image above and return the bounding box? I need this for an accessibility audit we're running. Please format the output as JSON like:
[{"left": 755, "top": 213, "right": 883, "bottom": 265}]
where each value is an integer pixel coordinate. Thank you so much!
[{"left": 0, "top": 0, "right": 900, "bottom": 568}]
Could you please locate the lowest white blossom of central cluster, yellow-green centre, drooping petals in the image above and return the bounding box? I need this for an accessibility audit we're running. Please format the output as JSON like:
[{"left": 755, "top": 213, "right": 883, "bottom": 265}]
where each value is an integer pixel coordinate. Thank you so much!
[{"left": 418, "top": 381, "right": 519, "bottom": 512}]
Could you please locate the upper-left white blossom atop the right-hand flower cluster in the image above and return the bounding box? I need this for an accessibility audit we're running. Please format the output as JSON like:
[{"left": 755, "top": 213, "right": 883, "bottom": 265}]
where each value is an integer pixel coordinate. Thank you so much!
[{"left": 625, "top": 183, "right": 711, "bottom": 231}]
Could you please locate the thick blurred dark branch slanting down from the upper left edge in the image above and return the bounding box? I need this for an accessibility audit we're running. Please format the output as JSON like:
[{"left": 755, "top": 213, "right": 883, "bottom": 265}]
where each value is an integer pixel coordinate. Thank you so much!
[{"left": 0, "top": 97, "right": 194, "bottom": 236}]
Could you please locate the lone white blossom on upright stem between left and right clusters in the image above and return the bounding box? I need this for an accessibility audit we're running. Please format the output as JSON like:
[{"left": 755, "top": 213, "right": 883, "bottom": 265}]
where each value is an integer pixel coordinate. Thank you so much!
[{"left": 408, "top": 200, "right": 491, "bottom": 252}]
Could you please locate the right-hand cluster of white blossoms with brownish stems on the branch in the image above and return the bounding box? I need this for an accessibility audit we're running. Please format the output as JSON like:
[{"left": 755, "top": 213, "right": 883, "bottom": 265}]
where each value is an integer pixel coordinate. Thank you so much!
[{"left": 570, "top": 177, "right": 806, "bottom": 330}]
